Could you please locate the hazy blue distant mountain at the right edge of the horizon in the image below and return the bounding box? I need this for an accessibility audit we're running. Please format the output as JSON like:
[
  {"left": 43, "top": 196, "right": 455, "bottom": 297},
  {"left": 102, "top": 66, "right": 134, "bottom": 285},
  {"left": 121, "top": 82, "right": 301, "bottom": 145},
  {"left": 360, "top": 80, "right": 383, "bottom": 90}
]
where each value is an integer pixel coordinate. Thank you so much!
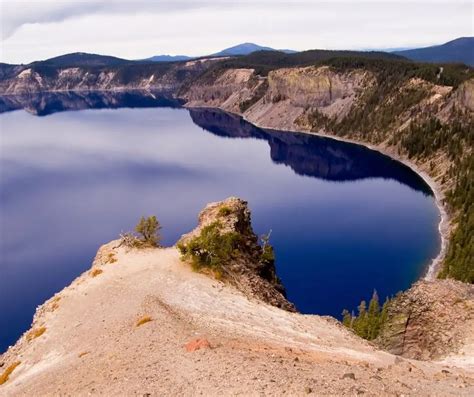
[{"left": 393, "top": 37, "right": 474, "bottom": 66}]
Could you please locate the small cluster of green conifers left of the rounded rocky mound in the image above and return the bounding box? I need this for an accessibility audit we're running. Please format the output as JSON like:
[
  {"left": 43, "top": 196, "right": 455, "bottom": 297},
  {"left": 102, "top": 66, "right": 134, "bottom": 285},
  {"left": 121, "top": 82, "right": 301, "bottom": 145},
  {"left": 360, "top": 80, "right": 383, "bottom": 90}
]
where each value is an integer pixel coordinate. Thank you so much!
[{"left": 342, "top": 291, "right": 390, "bottom": 340}]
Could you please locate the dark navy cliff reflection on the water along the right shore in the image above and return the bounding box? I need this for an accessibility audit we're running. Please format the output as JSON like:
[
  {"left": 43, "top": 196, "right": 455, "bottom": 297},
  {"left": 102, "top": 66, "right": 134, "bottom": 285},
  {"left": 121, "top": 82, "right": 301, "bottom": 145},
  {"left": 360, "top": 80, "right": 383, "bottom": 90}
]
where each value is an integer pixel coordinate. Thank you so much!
[{"left": 190, "top": 109, "right": 432, "bottom": 195}]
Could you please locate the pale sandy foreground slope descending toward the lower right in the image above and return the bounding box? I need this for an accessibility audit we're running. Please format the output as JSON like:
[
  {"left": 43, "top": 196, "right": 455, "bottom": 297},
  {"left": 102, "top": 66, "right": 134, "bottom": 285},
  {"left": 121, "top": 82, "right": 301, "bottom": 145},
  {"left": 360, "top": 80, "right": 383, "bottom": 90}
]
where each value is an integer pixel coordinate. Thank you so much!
[{"left": 0, "top": 199, "right": 474, "bottom": 396}]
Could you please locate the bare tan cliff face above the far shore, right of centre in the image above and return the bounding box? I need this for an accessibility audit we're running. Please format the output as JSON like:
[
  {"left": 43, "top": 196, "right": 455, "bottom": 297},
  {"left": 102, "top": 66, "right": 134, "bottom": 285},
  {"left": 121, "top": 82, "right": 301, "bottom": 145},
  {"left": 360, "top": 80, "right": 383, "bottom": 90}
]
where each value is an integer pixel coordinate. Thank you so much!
[{"left": 182, "top": 66, "right": 374, "bottom": 129}]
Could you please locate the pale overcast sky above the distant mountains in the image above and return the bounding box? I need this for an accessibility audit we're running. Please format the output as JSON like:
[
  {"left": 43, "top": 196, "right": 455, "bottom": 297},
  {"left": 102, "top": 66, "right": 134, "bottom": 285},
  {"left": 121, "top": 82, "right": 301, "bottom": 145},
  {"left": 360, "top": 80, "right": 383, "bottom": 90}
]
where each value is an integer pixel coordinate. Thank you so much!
[{"left": 0, "top": 0, "right": 474, "bottom": 63}]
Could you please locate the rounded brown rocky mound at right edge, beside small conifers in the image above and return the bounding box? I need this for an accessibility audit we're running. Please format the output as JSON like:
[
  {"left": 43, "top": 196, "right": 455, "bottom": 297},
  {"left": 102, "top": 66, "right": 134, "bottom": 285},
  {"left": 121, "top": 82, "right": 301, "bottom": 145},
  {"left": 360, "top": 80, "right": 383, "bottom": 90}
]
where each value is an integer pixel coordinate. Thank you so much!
[{"left": 377, "top": 280, "right": 474, "bottom": 360}]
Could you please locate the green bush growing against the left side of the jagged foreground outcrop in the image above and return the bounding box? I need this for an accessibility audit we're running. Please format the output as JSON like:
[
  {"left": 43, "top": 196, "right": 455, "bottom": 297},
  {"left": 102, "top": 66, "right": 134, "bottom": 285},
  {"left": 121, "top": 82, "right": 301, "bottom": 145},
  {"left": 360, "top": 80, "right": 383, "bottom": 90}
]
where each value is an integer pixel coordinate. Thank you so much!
[{"left": 177, "top": 221, "right": 241, "bottom": 272}]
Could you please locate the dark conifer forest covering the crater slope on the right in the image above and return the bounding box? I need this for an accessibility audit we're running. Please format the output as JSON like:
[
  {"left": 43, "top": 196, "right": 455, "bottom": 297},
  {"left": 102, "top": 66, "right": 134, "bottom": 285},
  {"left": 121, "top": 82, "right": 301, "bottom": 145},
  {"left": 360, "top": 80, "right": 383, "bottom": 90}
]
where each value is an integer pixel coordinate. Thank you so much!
[{"left": 302, "top": 58, "right": 474, "bottom": 283}]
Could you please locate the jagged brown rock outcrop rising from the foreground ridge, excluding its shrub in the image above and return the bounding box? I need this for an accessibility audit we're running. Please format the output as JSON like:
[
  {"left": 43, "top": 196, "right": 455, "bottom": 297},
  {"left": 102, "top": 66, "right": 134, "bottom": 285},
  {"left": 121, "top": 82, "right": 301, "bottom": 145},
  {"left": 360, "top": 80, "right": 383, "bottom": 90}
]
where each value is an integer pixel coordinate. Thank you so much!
[{"left": 177, "top": 197, "right": 295, "bottom": 311}]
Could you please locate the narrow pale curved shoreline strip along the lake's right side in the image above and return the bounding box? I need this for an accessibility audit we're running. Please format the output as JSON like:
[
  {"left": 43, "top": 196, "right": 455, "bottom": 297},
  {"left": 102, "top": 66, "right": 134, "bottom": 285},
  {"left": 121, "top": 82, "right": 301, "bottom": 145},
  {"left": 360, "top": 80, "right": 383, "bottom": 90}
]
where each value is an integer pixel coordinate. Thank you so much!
[{"left": 183, "top": 103, "right": 452, "bottom": 281}]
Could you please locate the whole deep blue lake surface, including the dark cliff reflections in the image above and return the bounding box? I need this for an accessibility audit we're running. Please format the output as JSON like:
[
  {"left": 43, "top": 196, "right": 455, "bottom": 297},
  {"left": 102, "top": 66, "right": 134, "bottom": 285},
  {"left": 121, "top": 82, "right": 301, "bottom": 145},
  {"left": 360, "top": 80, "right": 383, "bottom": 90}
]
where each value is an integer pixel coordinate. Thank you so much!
[{"left": 0, "top": 93, "right": 440, "bottom": 352}]
